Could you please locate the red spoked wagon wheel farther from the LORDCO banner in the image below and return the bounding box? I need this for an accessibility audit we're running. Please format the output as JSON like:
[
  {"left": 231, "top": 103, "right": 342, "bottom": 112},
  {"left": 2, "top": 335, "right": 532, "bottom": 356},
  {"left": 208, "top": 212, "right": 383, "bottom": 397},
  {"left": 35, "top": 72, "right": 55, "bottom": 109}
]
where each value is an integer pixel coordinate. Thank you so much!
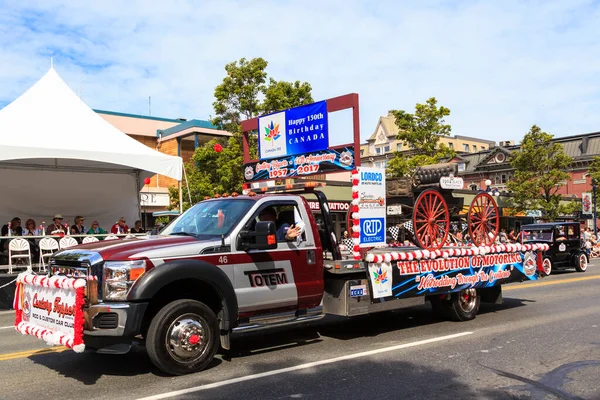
[{"left": 468, "top": 193, "right": 500, "bottom": 246}]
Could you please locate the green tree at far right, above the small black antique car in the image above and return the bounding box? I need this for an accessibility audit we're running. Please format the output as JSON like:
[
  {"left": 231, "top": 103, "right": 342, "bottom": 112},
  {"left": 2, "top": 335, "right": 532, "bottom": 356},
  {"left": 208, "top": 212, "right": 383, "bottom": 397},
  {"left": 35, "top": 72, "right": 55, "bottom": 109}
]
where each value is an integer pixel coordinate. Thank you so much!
[{"left": 508, "top": 125, "right": 577, "bottom": 221}]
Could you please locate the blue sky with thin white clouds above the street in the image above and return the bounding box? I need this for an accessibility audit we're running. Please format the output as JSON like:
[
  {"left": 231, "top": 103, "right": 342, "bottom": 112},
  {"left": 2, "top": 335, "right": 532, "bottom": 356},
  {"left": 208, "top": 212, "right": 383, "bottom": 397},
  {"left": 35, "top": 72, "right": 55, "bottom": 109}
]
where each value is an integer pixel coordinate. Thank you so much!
[{"left": 0, "top": 0, "right": 600, "bottom": 143}]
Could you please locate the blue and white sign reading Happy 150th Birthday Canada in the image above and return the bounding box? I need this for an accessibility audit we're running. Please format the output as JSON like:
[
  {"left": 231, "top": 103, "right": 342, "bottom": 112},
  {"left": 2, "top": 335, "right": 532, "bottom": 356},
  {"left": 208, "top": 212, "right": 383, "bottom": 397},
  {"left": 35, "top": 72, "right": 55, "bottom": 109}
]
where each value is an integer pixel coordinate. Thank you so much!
[{"left": 258, "top": 101, "right": 329, "bottom": 160}]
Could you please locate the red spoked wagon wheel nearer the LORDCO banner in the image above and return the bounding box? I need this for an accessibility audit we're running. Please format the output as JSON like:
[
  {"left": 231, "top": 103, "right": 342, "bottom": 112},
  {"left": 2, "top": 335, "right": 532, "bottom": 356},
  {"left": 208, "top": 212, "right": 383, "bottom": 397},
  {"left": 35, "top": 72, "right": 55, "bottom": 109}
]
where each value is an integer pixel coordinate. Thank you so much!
[{"left": 413, "top": 189, "right": 450, "bottom": 250}]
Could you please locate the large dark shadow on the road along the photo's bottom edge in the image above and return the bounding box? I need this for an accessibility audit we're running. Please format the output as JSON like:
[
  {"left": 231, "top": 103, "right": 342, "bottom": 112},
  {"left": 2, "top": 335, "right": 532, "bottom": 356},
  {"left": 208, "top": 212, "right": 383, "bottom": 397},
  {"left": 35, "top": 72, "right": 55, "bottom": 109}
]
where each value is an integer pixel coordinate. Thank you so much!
[{"left": 172, "top": 354, "right": 529, "bottom": 400}]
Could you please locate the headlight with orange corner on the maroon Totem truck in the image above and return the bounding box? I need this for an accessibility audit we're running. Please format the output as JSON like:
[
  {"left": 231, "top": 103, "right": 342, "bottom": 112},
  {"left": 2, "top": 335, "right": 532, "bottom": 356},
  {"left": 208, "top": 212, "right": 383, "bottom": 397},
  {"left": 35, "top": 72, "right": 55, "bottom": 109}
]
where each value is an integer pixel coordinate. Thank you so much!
[{"left": 102, "top": 260, "right": 146, "bottom": 300}]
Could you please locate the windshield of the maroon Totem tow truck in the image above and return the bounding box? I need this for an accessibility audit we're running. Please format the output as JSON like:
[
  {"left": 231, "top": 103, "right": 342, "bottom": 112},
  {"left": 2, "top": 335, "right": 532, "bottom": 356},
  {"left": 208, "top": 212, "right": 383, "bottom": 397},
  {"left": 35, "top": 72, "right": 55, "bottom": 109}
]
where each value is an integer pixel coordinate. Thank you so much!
[{"left": 160, "top": 199, "right": 254, "bottom": 238}]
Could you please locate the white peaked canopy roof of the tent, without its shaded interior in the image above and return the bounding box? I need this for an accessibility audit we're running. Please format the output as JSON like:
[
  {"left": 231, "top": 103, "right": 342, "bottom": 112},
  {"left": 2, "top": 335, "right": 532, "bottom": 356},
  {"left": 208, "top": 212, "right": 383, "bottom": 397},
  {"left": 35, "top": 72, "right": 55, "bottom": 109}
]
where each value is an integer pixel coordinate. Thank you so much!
[{"left": 0, "top": 68, "right": 183, "bottom": 181}]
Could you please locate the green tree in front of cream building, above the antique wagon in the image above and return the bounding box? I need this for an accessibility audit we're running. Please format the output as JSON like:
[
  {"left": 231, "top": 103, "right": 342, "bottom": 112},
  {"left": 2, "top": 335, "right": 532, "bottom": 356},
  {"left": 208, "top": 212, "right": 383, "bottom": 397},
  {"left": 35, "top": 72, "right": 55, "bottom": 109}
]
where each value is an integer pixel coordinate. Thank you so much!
[{"left": 388, "top": 97, "right": 456, "bottom": 177}]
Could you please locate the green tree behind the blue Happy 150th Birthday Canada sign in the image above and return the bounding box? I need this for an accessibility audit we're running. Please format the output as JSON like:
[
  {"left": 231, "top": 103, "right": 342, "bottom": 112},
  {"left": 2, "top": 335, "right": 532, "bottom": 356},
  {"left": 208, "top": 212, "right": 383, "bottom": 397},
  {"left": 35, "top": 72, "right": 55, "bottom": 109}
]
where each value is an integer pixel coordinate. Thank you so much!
[{"left": 170, "top": 58, "right": 313, "bottom": 209}]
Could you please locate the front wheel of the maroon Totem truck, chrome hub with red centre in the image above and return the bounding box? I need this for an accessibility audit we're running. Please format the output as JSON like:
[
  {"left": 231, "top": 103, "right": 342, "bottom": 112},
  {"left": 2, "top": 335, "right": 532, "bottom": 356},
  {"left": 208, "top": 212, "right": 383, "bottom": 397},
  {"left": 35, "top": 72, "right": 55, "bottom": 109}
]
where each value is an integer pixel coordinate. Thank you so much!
[{"left": 146, "top": 299, "right": 219, "bottom": 375}]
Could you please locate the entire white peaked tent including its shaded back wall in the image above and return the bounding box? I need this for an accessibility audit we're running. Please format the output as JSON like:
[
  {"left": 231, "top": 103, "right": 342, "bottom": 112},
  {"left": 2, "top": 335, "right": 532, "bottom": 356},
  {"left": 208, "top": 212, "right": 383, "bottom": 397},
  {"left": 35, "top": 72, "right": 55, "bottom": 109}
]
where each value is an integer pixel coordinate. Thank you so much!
[{"left": 0, "top": 68, "right": 183, "bottom": 230}]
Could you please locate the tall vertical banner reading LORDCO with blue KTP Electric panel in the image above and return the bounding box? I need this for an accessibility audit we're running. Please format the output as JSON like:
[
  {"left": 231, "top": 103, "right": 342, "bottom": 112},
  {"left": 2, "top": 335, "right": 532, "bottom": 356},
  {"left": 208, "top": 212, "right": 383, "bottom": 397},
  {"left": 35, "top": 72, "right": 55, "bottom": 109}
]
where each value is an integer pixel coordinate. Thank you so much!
[{"left": 357, "top": 167, "right": 387, "bottom": 246}]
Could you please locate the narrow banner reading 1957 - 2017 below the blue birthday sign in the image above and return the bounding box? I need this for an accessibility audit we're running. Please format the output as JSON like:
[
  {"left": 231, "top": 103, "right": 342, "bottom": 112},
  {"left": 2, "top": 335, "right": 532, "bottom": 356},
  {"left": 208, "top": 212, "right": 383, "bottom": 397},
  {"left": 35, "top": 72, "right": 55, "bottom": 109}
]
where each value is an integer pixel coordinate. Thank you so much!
[{"left": 244, "top": 147, "right": 354, "bottom": 182}]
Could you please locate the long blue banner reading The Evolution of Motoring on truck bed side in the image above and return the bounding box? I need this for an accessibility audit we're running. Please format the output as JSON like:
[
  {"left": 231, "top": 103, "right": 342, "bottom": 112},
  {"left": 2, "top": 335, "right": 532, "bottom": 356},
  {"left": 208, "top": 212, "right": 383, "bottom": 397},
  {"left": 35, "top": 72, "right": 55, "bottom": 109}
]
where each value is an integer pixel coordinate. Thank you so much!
[{"left": 369, "top": 251, "right": 541, "bottom": 300}]
